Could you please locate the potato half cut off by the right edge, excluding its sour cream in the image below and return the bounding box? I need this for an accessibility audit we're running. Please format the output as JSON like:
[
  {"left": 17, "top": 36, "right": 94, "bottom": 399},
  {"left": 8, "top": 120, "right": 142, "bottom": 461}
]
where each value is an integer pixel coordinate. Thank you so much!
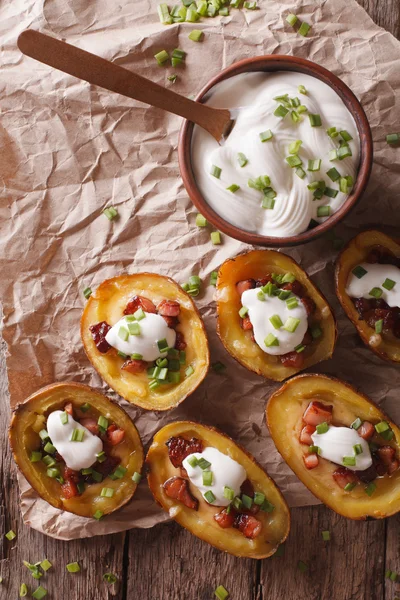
[{"left": 335, "top": 230, "right": 400, "bottom": 363}]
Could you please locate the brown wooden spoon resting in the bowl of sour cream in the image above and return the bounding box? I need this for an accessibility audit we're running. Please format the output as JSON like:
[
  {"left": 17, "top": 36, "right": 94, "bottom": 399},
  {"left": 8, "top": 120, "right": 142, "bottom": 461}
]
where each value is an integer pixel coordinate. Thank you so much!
[{"left": 18, "top": 29, "right": 234, "bottom": 143}]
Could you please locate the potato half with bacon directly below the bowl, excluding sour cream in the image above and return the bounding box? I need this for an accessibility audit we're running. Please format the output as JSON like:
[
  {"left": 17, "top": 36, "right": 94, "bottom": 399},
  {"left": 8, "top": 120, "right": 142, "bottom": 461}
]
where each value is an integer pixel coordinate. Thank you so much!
[{"left": 217, "top": 250, "right": 337, "bottom": 381}]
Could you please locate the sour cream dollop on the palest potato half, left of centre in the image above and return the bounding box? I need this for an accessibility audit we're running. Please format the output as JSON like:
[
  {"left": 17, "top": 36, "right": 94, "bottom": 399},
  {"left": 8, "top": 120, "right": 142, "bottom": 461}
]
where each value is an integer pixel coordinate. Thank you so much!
[{"left": 106, "top": 312, "right": 176, "bottom": 362}]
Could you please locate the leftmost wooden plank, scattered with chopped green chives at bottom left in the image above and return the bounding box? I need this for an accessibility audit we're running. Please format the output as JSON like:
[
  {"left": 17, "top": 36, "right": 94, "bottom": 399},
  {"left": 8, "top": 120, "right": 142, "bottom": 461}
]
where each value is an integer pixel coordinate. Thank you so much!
[{"left": 0, "top": 351, "right": 126, "bottom": 600}]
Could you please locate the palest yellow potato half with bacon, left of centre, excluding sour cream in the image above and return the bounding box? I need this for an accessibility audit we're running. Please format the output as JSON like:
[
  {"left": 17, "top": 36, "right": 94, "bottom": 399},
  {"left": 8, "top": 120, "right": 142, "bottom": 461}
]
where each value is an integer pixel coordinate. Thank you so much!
[{"left": 81, "top": 273, "right": 210, "bottom": 410}]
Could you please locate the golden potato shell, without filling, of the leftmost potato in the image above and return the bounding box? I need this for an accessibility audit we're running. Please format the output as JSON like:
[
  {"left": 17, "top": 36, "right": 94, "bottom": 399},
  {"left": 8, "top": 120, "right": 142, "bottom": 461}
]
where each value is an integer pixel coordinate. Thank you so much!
[{"left": 9, "top": 382, "right": 144, "bottom": 517}]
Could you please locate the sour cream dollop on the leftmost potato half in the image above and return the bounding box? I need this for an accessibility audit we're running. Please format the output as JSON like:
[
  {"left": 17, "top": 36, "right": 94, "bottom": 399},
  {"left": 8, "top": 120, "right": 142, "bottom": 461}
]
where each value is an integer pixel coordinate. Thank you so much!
[{"left": 47, "top": 410, "right": 103, "bottom": 471}]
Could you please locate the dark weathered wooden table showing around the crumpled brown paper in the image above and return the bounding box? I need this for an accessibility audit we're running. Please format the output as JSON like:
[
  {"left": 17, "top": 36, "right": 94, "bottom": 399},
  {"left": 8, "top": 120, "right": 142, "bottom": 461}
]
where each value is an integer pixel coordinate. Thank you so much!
[{"left": 0, "top": 0, "right": 400, "bottom": 600}]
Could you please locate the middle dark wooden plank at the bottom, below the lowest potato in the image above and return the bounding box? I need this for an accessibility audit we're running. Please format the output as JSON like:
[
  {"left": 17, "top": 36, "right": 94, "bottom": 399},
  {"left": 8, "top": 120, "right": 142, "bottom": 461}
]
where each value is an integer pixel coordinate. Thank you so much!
[{"left": 126, "top": 523, "right": 257, "bottom": 600}]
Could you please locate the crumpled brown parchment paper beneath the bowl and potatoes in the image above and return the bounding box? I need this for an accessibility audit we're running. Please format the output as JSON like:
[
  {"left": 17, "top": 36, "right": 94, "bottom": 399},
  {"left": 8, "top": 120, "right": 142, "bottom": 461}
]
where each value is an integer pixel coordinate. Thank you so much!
[{"left": 0, "top": 0, "right": 400, "bottom": 539}]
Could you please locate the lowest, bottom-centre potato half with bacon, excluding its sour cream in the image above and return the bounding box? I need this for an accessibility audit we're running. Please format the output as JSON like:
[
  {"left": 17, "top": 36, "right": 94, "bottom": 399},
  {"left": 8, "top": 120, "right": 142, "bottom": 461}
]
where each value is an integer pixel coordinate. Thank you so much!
[{"left": 146, "top": 421, "right": 290, "bottom": 558}]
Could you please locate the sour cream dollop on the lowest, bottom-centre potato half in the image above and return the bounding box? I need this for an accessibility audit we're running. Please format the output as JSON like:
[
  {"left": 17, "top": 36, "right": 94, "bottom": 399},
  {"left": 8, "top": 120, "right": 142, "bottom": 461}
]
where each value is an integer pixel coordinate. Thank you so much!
[{"left": 182, "top": 446, "right": 247, "bottom": 506}]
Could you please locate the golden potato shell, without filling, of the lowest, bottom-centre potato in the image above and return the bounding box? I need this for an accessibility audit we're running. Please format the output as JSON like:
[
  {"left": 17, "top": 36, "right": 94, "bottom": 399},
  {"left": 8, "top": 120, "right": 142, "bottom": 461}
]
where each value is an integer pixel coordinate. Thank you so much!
[{"left": 146, "top": 421, "right": 290, "bottom": 559}]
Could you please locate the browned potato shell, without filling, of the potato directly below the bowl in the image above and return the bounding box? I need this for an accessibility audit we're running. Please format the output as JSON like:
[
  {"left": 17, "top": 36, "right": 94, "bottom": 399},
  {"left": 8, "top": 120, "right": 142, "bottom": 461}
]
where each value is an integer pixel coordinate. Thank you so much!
[{"left": 217, "top": 250, "right": 337, "bottom": 381}]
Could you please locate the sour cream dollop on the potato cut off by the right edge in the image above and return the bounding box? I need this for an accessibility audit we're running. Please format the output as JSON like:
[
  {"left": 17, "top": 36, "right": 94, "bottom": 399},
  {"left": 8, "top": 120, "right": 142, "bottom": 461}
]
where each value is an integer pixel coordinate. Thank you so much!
[{"left": 346, "top": 263, "right": 400, "bottom": 307}]
